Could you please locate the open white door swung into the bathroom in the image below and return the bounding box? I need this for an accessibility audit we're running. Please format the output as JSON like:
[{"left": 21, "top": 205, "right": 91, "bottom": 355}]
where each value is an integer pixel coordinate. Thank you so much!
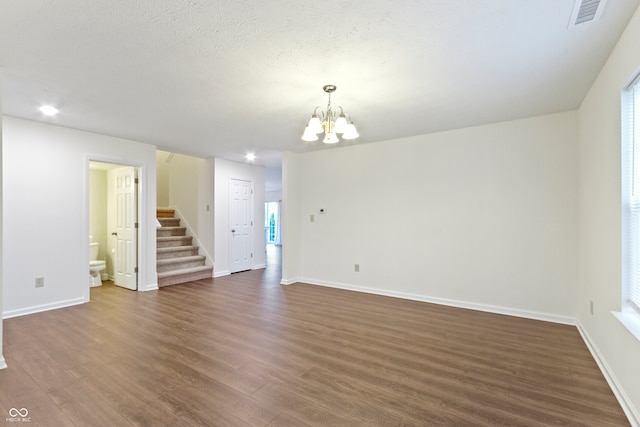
[{"left": 114, "top": 167, "right": 138, "bottom": 290}]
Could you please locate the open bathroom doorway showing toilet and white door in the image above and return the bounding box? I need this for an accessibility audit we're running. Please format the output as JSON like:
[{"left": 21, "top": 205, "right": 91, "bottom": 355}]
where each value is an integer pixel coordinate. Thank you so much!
[{"left": 88, "top": 161, "right": 139, "bottom": 290}]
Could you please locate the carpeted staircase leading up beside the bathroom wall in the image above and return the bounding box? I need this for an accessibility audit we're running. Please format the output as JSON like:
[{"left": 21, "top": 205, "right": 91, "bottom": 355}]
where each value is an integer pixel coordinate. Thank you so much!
[{"left": 156, "top": 209, "right": 213, "bottom": 287}]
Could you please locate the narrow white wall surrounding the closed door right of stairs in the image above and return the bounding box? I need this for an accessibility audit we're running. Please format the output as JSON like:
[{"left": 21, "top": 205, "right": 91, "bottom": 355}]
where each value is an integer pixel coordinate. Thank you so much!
[{"left": 213, "top": 159, "right": 266, "bottom": 277}]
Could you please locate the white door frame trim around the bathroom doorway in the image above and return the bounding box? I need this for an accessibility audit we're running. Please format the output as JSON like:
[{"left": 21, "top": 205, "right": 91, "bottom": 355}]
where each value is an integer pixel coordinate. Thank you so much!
[{"left": 81, "top": 155, "right": 146, "bottom": 302}]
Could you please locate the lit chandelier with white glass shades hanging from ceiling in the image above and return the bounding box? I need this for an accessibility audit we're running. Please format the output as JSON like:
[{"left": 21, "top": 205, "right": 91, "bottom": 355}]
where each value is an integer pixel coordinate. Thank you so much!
[{"left": 302, "top": 85, "right": 360, "bottom": 144}]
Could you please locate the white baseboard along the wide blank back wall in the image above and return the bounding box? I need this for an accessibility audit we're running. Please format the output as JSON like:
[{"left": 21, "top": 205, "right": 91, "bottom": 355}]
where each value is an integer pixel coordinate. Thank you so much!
[{"left": 298, "top": 278, "right": 576, "bottom": 325}]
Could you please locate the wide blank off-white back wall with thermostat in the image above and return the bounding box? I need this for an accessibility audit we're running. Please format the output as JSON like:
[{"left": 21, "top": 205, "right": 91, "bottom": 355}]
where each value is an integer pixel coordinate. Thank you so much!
[{"left": 283, "top": 112, "right": 577, "bottom": 323}]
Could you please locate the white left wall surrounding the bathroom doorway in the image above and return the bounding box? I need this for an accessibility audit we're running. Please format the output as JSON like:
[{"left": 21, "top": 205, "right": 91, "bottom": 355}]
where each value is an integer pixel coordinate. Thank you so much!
[{"left": 3, "top": 117, "right": 157, "bottom": 317}]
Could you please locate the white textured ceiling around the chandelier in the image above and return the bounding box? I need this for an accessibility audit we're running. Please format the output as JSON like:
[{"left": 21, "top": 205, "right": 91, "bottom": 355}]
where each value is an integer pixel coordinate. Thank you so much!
[{"left": 0, "top": 0, "right": 640, "bottom": 189}]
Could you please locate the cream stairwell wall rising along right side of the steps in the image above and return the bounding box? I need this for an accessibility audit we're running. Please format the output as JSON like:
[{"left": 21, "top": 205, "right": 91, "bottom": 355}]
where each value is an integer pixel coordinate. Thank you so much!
[{"left": 165, "top": 154, "right": 214, "bottom": 268}]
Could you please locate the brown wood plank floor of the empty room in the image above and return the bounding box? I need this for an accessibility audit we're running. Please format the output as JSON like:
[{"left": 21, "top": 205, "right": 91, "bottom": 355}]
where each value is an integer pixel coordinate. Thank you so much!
[{"left": 0, "top": 246, "right": 628, "bottom": 426}]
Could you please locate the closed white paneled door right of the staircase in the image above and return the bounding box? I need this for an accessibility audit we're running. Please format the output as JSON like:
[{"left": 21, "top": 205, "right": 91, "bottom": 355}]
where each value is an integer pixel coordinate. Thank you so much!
[{"left": 229, "top": 179, "right": 253, "bottom": 273}]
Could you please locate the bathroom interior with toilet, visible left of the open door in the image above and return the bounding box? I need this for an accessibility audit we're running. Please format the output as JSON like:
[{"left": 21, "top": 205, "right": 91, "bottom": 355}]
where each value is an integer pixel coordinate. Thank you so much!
[{"left": 88, "top": 161, "right": 136, "bottom": 287}]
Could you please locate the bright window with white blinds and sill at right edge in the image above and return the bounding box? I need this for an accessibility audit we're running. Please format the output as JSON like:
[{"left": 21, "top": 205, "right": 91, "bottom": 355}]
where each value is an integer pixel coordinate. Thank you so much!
[{"left": 615, "top": 74, "right": 640, "bottom": 339}]
